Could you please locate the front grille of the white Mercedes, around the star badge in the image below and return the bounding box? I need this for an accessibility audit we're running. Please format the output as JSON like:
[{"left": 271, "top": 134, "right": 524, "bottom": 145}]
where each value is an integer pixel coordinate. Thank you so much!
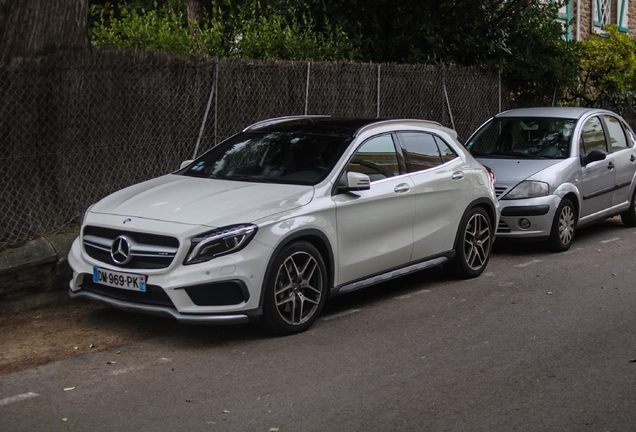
[{"left": 82, "top": 226, "right": 179, "bottom": 269}]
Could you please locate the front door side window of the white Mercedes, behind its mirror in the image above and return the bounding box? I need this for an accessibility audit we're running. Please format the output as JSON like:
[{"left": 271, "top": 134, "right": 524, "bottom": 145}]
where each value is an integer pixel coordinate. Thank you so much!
[{"left": 347, "top": 135, "right": 400, "bottom": 181}]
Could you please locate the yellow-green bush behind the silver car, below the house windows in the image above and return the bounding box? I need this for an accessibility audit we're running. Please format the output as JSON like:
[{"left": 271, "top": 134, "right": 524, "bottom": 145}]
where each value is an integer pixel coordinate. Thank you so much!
[{"left": 568, "top": 25, "right": 636, "bottom": 107}]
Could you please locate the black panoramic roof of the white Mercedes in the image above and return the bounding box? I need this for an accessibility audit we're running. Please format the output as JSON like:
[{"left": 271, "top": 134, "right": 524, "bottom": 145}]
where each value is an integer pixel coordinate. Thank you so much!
[{"left": 245, "top": 116, "right": 383, "bottom": 136}]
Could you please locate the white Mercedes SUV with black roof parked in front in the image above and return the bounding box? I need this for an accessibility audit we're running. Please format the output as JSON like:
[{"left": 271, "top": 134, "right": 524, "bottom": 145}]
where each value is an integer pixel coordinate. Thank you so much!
[{"left": 69, "top": 116, "right": 499, "bottom": 334}]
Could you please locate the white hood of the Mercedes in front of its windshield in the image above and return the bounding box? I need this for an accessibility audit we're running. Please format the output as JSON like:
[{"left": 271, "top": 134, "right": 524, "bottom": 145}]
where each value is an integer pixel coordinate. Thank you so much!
[{"left": 91, "top": 174, "right": 314, "bottom": 227}]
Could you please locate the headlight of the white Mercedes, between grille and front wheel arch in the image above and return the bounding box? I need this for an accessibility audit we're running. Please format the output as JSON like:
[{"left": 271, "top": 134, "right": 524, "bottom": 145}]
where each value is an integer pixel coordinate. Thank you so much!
[{"left": 183, "top": 224, "right": 258, "bottom": 265}]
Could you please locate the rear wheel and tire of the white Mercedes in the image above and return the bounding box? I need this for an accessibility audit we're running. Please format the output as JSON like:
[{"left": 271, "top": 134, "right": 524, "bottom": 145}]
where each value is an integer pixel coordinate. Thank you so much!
[{"left": 449, "top": 207, "right": 493, "bottom": 279}]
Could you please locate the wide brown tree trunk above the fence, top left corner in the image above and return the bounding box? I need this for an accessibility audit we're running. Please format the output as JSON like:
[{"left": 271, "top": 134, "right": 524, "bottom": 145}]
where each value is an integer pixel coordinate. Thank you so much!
[{"left": 0, "top": 0, "right": 88, "bottom": 62}]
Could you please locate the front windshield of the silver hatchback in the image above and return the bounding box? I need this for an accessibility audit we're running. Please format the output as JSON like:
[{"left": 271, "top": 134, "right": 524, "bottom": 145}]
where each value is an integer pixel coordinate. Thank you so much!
[{"left": 466, "top": 117, "right": 576, "bottom": 159}]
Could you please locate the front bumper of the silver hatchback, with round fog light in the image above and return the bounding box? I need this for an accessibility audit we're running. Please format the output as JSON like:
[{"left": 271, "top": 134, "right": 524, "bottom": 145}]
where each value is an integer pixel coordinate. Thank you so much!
[{"left": 497, "top": 195, "right": 561, "bottom": 240}]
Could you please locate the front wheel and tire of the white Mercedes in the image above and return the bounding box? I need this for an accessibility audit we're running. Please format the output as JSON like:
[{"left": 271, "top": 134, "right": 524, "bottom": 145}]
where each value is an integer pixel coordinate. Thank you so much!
[{"left": 260, "top": 241, "right": 329, "bottom": 335}]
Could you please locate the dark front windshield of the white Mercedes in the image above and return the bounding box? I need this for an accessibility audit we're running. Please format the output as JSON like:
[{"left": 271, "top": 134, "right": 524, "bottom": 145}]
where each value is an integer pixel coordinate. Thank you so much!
[{"left": 178, "top": 132, "right": 352, "bottom": 185}]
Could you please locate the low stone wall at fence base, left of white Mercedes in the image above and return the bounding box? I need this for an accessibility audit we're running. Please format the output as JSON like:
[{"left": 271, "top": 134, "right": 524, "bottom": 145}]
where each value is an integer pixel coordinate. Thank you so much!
[{"left": 0, "top": 231, "right": 78, "bottom": 313}]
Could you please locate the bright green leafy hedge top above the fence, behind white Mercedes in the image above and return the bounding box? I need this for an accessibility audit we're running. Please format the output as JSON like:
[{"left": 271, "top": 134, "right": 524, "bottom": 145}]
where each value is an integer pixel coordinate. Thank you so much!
[{"left": 91, "top": 0, "right": 355, "bottom": 60}]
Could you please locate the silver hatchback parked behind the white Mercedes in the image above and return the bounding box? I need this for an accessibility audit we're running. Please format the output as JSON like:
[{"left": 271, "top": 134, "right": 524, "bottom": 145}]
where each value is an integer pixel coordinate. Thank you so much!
[{"left": 466, "top": 107, "right": 636, "bottom": 251}]
